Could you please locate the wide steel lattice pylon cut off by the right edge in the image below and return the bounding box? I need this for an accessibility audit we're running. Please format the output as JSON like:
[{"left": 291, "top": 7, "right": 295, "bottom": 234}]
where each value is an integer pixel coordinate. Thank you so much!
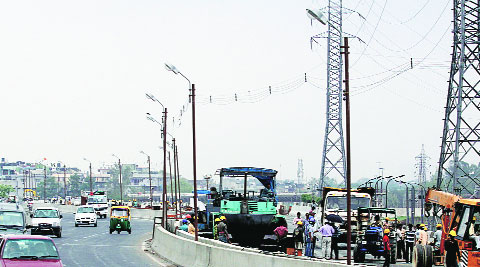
[{"left": 437, "top": 0, "right": 480, "bottom": 197}]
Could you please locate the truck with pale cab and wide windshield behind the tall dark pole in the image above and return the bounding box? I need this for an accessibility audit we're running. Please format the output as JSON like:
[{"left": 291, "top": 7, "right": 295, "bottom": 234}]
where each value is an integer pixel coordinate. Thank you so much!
[{"left": 320, "top": 187, "right": 375, "bottom": 246}]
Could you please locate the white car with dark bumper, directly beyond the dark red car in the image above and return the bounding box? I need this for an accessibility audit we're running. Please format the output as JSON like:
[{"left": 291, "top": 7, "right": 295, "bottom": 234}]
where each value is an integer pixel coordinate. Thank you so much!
[{"left": 30, "top": 207, "right": 63, "bottom": 237}]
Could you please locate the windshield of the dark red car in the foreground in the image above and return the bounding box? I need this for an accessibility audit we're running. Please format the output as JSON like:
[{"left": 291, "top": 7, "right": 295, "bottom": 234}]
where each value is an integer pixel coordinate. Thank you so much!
[{"left": 2, "top": 239, "right": 58, "bottom": 259}]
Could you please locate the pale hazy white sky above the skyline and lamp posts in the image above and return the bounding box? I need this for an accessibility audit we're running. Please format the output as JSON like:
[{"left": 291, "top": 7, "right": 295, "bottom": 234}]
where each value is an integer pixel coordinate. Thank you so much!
[{"left": 0, "top": 0, "right": 452, "bottom": 184}]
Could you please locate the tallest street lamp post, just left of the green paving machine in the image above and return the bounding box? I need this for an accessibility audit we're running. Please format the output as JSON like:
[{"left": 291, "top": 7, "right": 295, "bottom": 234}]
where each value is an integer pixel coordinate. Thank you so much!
[{"left": 165, "top": 63, "right": 198, "bottom": 241}]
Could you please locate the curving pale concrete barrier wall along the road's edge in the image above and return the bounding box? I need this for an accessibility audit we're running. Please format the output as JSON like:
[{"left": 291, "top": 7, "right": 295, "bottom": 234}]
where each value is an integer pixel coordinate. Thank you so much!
[{"left": 152, "top": 227, "right": 359, "bottom": 267}]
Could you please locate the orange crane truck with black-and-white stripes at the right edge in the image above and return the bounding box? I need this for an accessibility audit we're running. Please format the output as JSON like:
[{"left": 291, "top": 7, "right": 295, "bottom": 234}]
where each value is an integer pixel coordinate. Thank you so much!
[{"left": 418, "top": 188, "right": 480, "bottom": 267}]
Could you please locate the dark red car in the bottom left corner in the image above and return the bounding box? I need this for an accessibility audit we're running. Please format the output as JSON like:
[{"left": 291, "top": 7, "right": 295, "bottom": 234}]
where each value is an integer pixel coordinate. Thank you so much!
[{"left": 0, "top": 235, "right": 63, "bottom": 267}]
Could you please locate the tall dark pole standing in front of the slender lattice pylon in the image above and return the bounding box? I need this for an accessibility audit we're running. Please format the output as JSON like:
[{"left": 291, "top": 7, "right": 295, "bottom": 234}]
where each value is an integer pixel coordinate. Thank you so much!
[{"left": 342, "top": 37, "right": 352, "bottom": 265}]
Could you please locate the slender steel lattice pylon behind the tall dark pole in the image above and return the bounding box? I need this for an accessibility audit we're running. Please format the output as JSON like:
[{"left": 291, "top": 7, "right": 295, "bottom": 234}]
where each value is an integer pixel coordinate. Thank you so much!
[{"left": 320, "top": 0, "right": 347, "bottom": 189}]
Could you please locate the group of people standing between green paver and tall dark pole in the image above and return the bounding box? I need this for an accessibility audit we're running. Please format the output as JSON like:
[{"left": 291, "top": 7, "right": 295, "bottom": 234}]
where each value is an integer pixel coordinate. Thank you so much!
[{"left": 293, "top": 210, "right": 339, "bottom": 259}]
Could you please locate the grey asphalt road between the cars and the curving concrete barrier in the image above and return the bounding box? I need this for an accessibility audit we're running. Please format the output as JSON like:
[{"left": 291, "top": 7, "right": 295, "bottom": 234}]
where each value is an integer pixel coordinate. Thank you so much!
[{"left": 41, "top": 213, "right": 161, "bottom": 267}]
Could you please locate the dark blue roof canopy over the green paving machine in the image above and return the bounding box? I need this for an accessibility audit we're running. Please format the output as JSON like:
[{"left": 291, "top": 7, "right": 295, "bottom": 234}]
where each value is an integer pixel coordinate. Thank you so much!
[{"left": 216, "top": 167, "right": 278, "bottom": 187}]
